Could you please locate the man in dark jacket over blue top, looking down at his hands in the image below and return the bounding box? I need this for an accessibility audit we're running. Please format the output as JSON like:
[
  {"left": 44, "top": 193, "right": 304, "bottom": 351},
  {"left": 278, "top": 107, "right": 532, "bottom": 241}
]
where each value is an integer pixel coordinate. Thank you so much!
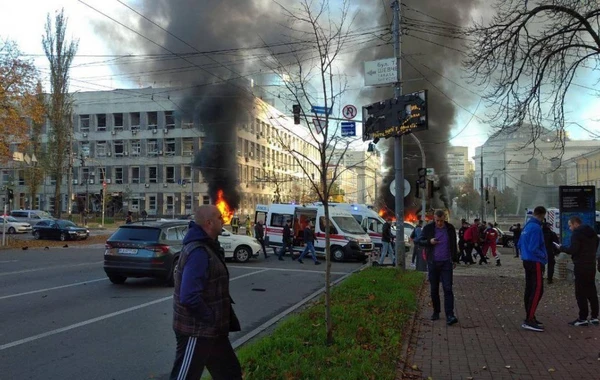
[{"left": 419, "top": 209, "right": 459, "bottom": 326}]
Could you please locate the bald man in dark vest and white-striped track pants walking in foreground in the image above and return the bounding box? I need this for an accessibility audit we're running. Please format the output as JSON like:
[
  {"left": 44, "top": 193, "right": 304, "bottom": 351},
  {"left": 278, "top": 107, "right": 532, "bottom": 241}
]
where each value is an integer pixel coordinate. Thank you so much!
[{"left": 171, "top": 205, "right": 242, "bottom": 380}]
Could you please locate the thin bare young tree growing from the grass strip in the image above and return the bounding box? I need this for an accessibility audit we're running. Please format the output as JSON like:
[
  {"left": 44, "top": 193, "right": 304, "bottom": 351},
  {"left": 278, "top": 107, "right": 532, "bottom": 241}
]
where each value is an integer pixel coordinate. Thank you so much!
[{"left": 258, "top": 0, "right": 378, "bottom": 344}]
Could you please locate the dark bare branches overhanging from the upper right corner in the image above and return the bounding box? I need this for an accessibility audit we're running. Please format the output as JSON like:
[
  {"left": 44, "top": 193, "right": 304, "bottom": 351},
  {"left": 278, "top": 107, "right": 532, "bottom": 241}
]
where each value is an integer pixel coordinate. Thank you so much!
[{"left": 465, "top": 0, "right": 600, "bottom": 152}]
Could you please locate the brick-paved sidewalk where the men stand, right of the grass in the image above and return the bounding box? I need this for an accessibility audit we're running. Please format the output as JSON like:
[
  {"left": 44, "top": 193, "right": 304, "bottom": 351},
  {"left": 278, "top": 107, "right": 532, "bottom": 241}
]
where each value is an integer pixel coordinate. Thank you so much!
[{"left": 398, "top": 250, "right": 600, "bottom": 380}]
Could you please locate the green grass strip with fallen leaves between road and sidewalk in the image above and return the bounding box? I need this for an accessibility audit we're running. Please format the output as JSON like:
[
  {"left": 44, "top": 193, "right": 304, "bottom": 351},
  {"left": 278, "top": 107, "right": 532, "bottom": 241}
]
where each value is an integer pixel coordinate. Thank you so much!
[{"left": 237, "top": 267, "right": 423, "bottom": 380}]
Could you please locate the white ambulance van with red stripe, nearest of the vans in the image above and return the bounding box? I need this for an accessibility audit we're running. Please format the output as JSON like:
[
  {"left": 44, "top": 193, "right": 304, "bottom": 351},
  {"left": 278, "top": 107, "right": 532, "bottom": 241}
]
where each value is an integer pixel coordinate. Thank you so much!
[{"left": 255, "top": 204, "right": 374, "bottom": 261}]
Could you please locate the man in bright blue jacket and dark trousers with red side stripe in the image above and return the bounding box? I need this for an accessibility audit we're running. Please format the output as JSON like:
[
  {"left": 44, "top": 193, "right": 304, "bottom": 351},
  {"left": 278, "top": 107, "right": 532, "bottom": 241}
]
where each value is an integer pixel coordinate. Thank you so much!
[{"left": 518, "top": 206, "right": 548, "bottom": 332}]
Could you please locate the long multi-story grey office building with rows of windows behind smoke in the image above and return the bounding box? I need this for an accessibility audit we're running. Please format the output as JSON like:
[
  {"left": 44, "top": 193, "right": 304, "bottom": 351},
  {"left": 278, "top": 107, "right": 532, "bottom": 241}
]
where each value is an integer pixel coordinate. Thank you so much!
[{"left": 1, "top": 88, "right": 319, "bottom": 216}]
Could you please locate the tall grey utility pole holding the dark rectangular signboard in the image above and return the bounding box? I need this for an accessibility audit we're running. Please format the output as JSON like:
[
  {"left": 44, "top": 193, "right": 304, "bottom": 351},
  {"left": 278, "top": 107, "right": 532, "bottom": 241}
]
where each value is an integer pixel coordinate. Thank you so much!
[{"left": 392, "top": 0, "right": 406, "bottom": 269}]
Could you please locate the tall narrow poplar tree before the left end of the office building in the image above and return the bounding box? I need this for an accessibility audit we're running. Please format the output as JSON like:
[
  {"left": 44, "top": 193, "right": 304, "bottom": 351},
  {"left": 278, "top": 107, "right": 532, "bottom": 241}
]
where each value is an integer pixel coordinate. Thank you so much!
[{"left": 42, "top": 10, "right": 78, "bottom": 217}]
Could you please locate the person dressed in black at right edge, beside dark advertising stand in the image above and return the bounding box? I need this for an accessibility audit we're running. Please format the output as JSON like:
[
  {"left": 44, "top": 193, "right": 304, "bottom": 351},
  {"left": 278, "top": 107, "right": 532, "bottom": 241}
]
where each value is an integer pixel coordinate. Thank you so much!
[{"left": 557, "top": 216, "right": 600, "bottom": 326}]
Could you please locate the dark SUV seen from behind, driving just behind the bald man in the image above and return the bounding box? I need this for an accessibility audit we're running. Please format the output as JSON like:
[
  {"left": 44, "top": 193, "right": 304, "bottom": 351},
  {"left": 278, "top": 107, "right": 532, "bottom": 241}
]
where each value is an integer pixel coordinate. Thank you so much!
[{"left": 104, "top": 219, "right": 189, "bottom": 286}]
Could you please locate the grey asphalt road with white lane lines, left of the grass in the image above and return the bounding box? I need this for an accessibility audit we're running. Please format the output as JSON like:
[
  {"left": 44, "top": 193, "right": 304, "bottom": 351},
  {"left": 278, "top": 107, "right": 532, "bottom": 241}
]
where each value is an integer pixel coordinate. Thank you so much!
[{"left": 0, "top": 246, "right": 362, "bottom": 380}]
